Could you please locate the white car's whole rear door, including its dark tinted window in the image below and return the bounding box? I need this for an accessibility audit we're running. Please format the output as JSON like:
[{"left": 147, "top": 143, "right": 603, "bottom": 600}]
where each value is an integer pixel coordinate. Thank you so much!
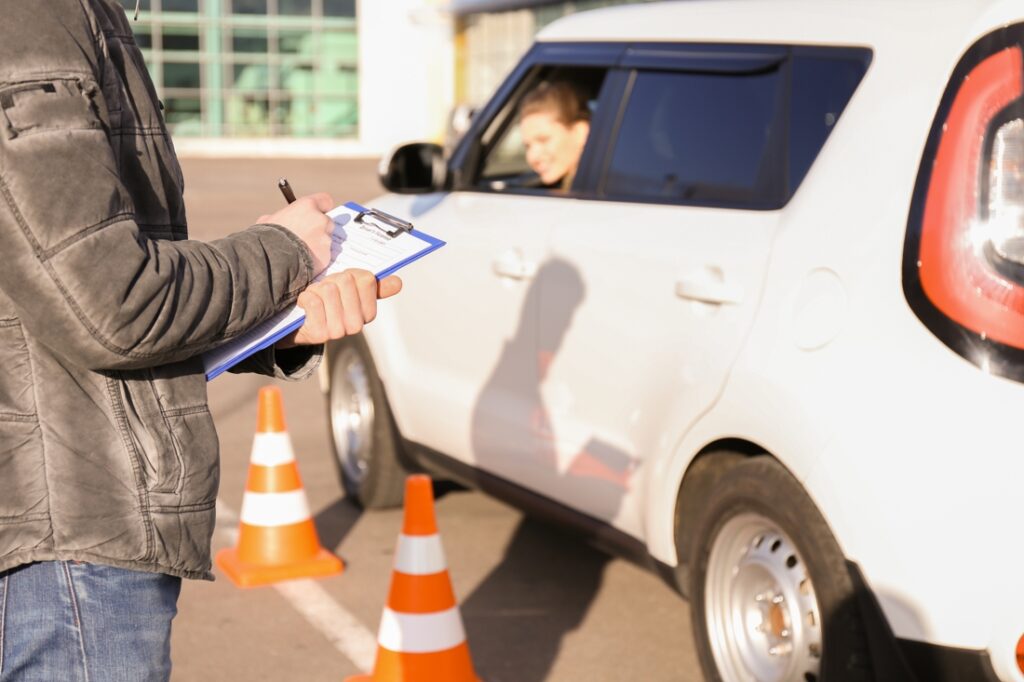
[{"left": 538, "top": 48, "right": 786, "bottom": 537}]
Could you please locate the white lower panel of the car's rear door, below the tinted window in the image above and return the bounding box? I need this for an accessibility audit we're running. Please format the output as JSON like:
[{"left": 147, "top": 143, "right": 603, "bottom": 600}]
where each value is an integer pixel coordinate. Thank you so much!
[{"left": 538, "top": 201, "right": 778, "bottom": 537}]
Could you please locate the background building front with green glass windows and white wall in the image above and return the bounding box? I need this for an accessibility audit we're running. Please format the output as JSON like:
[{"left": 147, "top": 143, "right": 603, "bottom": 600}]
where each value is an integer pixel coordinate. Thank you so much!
[{"left": 121, "top": 0, "right": 644, "bottom": 156}]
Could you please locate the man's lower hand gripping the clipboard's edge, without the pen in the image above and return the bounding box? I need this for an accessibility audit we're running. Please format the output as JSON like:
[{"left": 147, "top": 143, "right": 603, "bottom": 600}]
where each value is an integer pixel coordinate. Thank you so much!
[{"left": 276, "top": 268, "right": 401, "bottom": 348}]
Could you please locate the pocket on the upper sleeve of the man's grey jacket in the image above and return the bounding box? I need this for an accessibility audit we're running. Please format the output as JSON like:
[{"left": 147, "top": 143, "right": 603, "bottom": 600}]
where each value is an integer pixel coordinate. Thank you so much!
[{"left": 0, "top": 78, "right": 103, "bottom": 139}]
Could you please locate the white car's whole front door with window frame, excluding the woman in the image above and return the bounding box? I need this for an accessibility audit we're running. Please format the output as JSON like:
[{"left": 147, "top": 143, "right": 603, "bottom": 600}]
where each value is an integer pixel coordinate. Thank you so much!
[{"left": 368, "top": 49, "right": 618, "bottom": 482}]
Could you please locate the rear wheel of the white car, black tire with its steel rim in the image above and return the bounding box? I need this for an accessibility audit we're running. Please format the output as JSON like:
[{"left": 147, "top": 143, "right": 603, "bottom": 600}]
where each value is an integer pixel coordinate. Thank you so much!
[{"left": 689, "top": 456, "right": 871, "bottom": 682}]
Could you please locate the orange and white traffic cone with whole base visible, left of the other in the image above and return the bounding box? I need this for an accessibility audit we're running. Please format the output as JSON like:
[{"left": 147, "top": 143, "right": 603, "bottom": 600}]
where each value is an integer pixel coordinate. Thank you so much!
[{"left": 217, "top": 386, "right": 344, "bottom": 587}]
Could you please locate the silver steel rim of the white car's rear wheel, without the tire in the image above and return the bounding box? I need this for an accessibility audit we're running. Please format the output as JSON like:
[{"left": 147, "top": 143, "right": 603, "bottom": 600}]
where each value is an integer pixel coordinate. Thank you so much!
[{"left": 705, "top": 513, "right": 821, "bottom": 682}]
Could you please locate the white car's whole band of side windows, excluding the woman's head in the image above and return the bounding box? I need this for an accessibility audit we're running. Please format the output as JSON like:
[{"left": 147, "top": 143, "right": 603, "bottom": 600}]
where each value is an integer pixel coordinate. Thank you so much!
[{"left": 459, "top": 43, "right": 871, "bottom": 204}]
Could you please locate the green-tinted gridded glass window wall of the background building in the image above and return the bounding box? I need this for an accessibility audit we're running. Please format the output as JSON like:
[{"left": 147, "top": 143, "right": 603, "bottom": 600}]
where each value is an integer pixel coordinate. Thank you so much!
[{"left": 121, "top": 0, "right": 358, "bottom": 137}]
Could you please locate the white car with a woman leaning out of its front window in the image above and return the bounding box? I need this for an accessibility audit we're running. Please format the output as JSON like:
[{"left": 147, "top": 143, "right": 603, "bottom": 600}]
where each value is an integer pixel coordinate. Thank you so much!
[{"left": 326, "top": 0, "right": 1024, "bottom": 682}]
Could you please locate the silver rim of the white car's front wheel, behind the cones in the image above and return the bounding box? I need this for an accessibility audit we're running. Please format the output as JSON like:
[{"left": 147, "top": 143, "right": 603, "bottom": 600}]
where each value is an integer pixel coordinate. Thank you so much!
[{"left": 331, "top": 348, "right": 374, "bottom": 487}]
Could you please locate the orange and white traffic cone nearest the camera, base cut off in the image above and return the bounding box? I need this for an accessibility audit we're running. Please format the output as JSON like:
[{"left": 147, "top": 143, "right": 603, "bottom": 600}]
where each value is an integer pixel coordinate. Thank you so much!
[{"left": 346, "top": 475, "right": 479, "bottom": 682}]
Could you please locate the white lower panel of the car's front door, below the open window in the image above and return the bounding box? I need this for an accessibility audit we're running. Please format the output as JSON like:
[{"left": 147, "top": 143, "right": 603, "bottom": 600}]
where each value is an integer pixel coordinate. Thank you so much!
[{"left": 368, "top": 186, "right": 557, "bottom": 473}]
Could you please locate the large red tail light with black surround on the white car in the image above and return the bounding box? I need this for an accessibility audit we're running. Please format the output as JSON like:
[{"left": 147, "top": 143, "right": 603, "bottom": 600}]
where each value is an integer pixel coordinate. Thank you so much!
[{"left": 903, "top": 27, "right": 1024, "bottom": 380}]
